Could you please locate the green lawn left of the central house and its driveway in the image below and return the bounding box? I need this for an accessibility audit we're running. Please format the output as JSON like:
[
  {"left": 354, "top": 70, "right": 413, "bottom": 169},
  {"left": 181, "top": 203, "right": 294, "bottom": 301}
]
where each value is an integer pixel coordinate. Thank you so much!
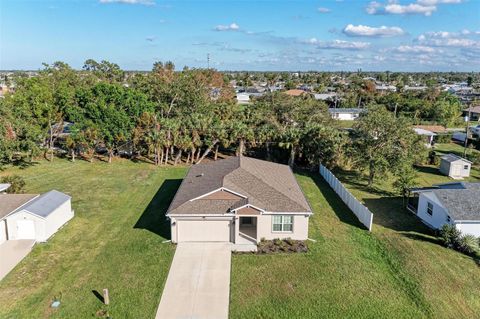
[{"left": 0, "top": 159, "right": 186, "bottom": 318}]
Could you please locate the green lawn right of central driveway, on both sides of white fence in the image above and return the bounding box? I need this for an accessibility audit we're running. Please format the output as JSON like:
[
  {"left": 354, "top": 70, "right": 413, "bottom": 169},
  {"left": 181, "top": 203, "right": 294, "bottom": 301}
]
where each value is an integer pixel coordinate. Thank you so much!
[{"left": 230, "top": 167, "right": 480, "bottom": 318}]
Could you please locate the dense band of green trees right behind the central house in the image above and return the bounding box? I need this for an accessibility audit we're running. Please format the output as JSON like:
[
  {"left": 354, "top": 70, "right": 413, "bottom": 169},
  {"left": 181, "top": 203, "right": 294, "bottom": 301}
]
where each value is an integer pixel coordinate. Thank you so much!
[{"left": 0, "top": 60, "right": 428, "bottom": 194}]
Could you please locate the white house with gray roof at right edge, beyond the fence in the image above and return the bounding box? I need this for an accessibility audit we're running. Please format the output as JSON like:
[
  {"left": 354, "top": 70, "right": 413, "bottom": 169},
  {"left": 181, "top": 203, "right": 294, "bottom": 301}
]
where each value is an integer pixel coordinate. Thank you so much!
[{"left": 407, "top": 182, "right": 480, "bottom": 237}]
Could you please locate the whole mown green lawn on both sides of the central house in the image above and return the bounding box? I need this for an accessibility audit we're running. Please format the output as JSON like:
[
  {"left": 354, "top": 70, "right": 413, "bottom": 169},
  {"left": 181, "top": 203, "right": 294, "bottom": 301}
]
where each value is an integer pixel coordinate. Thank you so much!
[{"left": 0, "top": 160, "right": 480, "bottom": 319}]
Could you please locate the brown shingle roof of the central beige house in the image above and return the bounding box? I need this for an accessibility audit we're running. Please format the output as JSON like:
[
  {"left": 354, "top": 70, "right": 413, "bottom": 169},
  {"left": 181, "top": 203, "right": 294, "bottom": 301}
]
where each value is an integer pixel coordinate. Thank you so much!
[{"left": 167, "top": 157, "right": 311, "bottom": 215}]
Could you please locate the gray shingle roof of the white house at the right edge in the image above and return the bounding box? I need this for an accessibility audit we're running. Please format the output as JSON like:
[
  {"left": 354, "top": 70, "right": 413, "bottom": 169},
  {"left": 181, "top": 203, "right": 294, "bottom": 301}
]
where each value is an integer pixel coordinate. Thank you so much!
[{"left": 433, "top": 183, "right": 480, "bottom": 221}]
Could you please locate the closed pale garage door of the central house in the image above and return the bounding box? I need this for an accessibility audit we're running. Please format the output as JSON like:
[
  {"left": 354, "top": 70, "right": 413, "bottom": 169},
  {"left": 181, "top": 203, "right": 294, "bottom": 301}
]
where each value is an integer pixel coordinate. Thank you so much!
[{"left": 177, "top": 220, "right": 231, "bottom": 242}]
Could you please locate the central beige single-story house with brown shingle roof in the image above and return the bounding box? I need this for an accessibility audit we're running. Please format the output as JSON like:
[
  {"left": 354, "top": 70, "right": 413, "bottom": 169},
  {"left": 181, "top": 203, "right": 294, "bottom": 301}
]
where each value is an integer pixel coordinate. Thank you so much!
[{"left": 166, "top": 156, "right": 312, "bottom": 245}]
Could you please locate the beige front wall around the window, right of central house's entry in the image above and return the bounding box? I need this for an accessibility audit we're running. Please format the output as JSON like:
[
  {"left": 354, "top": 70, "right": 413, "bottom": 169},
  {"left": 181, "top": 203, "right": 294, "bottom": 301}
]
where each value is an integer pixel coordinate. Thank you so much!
[{"left": 257, "top": 214, "right": 309, "bottom": 240}]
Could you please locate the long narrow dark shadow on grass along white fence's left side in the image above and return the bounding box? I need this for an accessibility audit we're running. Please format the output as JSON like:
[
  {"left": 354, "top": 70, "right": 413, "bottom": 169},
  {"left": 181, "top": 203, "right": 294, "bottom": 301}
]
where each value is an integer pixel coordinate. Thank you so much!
[{"left": 295, "top": 170, "right": 366, "bottom": 229}]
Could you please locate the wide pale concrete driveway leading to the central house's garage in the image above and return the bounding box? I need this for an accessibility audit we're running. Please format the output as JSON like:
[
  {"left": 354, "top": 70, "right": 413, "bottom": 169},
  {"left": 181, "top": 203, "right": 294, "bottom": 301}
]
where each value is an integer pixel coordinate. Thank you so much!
[{"left": 156, "top": 243, "right": 231, "bottom": 319}]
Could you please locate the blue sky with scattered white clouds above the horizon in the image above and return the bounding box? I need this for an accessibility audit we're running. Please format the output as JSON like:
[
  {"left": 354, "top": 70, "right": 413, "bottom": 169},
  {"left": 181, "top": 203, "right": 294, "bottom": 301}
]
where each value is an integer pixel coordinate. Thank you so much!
[{"left": 0, "top": 0, "right": 480, "bottom": 71}]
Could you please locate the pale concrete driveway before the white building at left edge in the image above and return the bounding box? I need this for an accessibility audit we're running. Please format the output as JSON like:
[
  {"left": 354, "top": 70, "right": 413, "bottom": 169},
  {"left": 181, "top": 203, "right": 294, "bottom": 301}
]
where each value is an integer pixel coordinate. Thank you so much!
[{"left": 0, "top": 239, "right": 35, "bottom": 280}]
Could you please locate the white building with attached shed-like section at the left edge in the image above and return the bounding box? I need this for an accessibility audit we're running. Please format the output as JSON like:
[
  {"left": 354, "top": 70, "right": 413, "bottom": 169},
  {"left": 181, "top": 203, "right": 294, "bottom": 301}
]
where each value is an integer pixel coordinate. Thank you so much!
[{"left": 0, "top": 190, "right": 74, "bottom": 244}]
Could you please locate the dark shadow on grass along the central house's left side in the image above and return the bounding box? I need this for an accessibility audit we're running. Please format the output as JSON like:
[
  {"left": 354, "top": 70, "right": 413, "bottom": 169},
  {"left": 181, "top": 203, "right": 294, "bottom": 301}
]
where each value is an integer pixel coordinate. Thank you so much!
[{"left": 133, "top": 179, "right": 182, "bottom": 239}]
